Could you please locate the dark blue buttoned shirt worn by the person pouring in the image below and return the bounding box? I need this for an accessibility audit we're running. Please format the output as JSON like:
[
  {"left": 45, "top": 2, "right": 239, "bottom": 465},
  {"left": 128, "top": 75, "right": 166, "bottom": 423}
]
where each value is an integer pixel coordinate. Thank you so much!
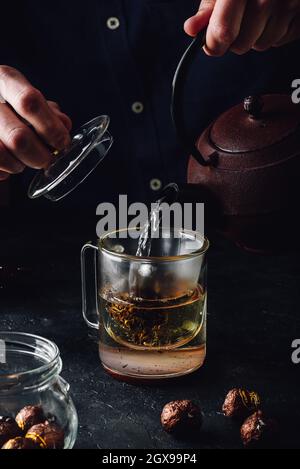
[{"left": 0, "top": 0, "right": 300, "bottom": 212}]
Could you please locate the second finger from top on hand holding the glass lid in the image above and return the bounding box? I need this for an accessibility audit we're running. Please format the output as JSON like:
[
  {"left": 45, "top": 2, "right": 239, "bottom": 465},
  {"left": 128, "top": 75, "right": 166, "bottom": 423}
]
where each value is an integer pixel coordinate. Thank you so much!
[{"left": 0, "top": 104, "right": 52, "bottom": 169}]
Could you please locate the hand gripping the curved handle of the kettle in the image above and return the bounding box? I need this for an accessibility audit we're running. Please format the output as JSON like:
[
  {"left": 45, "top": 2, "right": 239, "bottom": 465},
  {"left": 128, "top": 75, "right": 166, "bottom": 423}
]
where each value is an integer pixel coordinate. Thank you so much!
[{"left": 184, "top": 0, "right": 300, "bottom": 56}]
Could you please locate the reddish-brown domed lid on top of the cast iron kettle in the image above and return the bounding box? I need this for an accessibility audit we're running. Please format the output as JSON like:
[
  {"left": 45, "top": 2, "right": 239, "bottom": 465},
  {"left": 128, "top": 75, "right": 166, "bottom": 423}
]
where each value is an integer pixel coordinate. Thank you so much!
[{"left": 210, "top": 94, "right": 300, "bottom": 153}]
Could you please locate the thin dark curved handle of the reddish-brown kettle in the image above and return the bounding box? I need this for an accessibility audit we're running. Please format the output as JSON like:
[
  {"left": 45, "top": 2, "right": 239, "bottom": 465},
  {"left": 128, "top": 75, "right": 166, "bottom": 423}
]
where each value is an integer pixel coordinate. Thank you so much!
[{"left": 171, "top": 28, "right": 211, "bottom": 166}]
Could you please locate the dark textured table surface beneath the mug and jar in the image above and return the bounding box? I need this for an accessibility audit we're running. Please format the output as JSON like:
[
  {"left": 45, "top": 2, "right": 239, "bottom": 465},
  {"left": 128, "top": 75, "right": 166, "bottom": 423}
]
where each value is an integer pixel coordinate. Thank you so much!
[{"left": 0, "top": 210, "right": 300, "bottom": 449}]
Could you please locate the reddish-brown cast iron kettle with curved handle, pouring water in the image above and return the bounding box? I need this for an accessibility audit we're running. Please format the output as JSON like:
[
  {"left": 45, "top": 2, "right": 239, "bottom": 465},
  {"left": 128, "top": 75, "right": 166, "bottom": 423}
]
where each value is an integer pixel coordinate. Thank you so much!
[{"left": 172, "top": 31, "right": 300, "bottom": 252}]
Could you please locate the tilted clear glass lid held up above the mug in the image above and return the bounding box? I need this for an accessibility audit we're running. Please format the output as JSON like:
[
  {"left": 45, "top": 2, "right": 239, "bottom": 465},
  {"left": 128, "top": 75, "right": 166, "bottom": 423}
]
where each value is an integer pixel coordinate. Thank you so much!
[{"left": 28, "top": 116, "right": 113, "bottom": 201}]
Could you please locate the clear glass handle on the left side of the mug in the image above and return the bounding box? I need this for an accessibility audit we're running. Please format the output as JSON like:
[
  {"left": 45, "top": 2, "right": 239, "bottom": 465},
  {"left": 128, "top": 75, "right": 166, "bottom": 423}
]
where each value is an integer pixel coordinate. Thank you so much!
[{"left": 81, "top": 243, "right": 99, "bottom": 329}]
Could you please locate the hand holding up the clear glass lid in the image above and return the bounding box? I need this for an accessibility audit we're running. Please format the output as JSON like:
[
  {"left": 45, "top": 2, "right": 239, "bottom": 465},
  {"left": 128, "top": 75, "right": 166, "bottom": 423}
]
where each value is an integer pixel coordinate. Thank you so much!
[{"left": 0, "top": 65, "right": 72, "bottom": 181}]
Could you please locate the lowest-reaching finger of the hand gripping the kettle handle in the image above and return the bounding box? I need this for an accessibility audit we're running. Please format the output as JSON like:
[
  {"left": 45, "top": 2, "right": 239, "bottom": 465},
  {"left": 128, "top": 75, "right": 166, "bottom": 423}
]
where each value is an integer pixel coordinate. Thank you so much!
[{"left": 205, "top": 0, "right": 247, "bottom": 56}]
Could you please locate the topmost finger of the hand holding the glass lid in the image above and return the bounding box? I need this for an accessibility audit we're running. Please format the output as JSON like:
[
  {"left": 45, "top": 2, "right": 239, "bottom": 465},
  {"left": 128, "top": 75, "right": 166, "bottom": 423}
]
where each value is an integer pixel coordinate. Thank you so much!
[{"left": 0, "top": 66, "right": 70, "bottom": 150}]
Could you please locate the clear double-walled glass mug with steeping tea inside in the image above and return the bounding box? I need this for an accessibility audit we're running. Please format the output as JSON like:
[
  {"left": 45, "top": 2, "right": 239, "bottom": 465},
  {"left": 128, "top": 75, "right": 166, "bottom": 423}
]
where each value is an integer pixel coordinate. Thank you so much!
[{"left": 81, "top": 229, "right": 209, "bottom": 379}]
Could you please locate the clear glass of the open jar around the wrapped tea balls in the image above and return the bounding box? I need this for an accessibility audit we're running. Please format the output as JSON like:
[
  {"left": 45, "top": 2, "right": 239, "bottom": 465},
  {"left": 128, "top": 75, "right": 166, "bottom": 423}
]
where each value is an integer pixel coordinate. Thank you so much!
[{"left": 0, "top": 332, "right": 78, "bottom": 449}]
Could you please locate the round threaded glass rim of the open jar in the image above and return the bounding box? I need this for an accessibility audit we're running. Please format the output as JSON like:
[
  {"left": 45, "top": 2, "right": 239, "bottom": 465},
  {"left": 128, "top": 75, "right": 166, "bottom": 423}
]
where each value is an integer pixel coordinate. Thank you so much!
[{"left": 0, "top": 331, "right": 62, "bottom": 393}]
